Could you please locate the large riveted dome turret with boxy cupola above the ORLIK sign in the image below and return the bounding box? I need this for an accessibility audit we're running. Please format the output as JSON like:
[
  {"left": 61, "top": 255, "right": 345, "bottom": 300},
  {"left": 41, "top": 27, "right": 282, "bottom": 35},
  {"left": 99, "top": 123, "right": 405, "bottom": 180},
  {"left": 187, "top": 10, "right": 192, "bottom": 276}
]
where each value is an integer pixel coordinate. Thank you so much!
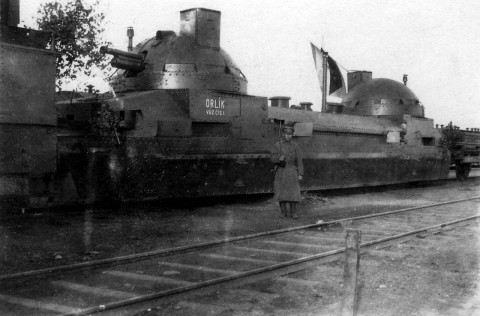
[{"left": 105, "top": 8, "right": 247, "bottom": 94}]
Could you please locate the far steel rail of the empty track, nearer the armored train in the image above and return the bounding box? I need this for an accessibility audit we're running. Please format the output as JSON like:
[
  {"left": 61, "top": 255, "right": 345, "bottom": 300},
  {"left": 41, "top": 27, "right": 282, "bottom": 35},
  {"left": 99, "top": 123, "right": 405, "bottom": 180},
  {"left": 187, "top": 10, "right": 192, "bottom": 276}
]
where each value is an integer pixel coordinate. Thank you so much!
[{"left": 0, "top": 196, "right": 480, "bottom": 281}]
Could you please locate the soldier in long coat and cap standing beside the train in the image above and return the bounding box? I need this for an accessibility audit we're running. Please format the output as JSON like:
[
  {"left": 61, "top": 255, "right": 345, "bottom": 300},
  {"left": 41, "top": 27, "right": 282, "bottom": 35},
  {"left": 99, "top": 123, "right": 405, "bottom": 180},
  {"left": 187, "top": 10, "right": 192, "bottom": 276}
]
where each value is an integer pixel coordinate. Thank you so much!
[{"left": 271, "top": 125, "right": 303, "bottom": 219}]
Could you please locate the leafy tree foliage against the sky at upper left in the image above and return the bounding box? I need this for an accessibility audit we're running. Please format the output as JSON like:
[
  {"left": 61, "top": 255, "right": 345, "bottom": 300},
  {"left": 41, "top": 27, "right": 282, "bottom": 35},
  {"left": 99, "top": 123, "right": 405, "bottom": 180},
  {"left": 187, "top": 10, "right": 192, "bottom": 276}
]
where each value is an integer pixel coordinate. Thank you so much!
[{"left": 37, "top": 0, "right": 110, "bottom": 88}]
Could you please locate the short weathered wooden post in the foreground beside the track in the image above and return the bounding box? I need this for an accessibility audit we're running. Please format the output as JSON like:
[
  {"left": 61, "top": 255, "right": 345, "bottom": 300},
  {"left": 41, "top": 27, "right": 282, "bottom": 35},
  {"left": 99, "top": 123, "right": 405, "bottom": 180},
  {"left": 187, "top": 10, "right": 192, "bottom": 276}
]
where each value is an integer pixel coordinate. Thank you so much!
[{"left": 340, "top": 229, "right": 361, "bottom": 316}]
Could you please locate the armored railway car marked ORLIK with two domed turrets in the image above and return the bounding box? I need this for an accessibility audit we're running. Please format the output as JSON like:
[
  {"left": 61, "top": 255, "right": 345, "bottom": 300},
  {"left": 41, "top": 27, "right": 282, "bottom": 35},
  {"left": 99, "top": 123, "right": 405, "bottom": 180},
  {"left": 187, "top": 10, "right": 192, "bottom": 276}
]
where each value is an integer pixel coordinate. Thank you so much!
[{"left": 57, "top": 8, "right": 450, "bottom": 201}]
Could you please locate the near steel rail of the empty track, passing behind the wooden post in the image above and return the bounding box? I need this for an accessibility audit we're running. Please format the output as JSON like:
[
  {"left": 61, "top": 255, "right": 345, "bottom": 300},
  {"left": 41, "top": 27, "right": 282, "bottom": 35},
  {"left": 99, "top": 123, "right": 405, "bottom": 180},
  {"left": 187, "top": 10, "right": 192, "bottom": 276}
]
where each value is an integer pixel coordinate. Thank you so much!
[{"left": 62, "top": 215, "right": 480, "bottom": 316}]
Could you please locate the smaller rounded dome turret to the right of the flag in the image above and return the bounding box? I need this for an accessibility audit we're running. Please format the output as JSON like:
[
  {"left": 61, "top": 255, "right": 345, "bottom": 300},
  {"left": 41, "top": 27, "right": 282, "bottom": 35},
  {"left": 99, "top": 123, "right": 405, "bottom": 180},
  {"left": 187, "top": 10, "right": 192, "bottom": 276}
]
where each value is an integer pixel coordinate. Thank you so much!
[{"left": 342, "top": 78, "right": 424, "bottom": 117}]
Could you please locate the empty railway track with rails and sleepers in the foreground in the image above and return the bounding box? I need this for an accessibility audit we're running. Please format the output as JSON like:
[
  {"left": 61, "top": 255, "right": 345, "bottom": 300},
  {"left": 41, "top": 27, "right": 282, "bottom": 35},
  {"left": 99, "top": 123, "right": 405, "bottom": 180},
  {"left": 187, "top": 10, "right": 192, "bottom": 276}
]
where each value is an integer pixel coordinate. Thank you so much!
[{"left": 0, "top": 197, "right": 480, "bottom": 315}]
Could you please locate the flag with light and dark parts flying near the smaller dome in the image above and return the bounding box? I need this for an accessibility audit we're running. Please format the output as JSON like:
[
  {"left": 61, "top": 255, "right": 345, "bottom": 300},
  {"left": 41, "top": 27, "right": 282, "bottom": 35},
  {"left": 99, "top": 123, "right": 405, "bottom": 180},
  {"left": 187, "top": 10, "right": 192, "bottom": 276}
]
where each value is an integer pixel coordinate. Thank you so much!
[{"left": 310, "top": 43, "right": 346, "bottom": 98}]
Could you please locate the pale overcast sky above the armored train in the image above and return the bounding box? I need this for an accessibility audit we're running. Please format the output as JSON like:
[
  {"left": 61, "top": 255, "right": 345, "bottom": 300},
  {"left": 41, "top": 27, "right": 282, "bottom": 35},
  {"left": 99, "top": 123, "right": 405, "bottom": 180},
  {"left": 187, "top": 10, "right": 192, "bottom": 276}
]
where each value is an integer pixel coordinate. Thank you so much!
[{"left": 21, "top": 0, "right": 480, "bottom": 128}]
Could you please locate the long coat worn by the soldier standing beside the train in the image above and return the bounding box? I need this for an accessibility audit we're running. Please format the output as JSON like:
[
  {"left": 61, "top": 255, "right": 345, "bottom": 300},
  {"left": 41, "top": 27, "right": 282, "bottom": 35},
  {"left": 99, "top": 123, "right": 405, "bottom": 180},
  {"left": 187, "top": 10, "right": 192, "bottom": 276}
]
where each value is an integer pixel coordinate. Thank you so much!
[{"left": 271, "top": 139, "right": 303, "bottom": 202}]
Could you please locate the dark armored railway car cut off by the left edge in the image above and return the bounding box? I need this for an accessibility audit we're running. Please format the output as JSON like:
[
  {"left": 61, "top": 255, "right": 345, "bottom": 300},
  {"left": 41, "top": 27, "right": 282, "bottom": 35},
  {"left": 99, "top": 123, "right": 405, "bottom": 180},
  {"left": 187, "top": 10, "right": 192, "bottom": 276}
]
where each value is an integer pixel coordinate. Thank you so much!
[{"left": 0, "top": 0, "right": 57, "bottom": 210}]
